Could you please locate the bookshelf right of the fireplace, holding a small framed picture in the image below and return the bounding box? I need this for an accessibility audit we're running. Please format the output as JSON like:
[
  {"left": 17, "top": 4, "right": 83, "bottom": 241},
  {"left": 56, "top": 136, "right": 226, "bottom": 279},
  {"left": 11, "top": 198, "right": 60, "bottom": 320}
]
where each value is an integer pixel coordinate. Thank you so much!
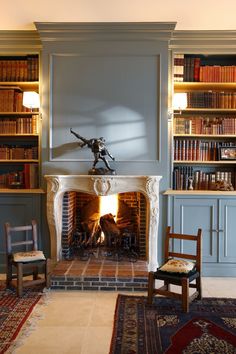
[{"left": 172, "top": 54, "right": 236, "bottom": 192}]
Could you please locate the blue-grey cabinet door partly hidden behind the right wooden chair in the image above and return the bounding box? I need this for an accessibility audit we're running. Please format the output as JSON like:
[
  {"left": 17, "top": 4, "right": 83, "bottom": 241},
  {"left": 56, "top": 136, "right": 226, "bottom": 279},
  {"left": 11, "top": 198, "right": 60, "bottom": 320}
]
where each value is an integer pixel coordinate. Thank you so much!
[{"left": 174, "top": 197, "right": 217, "bottom": 262}]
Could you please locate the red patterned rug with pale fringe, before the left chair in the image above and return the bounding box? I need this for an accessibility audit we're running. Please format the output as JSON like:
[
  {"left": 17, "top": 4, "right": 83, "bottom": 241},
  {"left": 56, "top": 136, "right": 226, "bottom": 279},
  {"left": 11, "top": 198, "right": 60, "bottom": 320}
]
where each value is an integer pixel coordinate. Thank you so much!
[{"left": 0, "top": 281, "right": 46, "bottom": 354}]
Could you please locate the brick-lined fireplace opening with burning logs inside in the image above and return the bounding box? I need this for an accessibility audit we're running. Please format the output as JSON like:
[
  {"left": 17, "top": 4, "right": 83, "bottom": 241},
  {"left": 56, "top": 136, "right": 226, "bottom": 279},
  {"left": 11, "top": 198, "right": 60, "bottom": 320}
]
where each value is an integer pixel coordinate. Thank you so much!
[{"left": 61, "top": 191, "right": 148, "bottom": 262}]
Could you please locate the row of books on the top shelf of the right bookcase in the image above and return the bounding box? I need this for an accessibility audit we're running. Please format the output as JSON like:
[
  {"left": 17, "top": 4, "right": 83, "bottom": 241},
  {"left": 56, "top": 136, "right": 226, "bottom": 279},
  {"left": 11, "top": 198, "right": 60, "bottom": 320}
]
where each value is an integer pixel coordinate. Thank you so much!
[{"left": 174, "top": 54, "right": 236, "bottom": 82}]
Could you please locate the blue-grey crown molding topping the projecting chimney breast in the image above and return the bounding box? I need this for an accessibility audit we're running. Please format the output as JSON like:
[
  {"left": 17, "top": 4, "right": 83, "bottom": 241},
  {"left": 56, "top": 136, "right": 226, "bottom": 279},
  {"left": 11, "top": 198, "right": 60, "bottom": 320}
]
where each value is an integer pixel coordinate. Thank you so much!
[{"left": 35, "top": 22, "right": 176, "bottom": 42}]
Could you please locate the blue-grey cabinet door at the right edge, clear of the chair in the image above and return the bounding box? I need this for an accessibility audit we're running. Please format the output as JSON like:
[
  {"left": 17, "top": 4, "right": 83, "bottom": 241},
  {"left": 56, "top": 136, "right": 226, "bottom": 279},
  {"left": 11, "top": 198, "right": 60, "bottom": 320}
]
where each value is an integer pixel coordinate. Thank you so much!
[{"left": 219, "top": 199, "right": 236, "bottom": 263}]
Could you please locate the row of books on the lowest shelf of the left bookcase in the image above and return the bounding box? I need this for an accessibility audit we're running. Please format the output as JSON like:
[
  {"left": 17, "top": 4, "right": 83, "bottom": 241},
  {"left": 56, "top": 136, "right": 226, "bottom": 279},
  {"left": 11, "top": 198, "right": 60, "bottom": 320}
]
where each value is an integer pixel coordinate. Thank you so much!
[{"left": 0, "top": 164, "right": 39, "bottom": 189}]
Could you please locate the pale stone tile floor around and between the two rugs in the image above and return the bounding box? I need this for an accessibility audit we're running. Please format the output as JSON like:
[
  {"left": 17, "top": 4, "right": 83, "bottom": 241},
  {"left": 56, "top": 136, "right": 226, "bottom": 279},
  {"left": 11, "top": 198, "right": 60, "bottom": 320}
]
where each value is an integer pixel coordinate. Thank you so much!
[{"left": 10, "top": 277, "right": 236, "bottom": 354}]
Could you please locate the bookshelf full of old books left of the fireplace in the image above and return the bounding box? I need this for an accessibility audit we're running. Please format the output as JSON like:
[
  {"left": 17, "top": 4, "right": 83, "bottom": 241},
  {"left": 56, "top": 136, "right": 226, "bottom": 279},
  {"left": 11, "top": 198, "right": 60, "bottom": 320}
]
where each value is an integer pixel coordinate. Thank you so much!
[{"left": 0, "top": 54, "right": 40, "bottom": 192}]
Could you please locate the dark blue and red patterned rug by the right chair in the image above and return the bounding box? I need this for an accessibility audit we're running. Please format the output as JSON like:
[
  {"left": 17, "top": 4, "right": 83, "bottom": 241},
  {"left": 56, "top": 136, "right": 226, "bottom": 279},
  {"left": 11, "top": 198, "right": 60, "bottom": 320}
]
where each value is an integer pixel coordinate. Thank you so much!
[{"left": 110, "top": 295, "right": 236, "bottom": 354}]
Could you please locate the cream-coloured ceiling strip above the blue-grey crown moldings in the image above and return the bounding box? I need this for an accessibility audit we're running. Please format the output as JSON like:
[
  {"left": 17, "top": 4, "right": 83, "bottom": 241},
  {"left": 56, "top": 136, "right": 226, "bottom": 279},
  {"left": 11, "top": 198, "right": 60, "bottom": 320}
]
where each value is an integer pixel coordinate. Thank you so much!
[{"left": 0, "top": 0, "right": 236, "bottom": 30}]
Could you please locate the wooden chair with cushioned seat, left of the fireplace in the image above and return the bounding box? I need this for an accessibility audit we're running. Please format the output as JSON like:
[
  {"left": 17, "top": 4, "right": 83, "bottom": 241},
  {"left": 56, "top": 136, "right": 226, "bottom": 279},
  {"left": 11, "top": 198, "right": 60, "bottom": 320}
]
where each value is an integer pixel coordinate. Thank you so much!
[{"left": 5, "top": 220, "right": 50, "bottom": 297}]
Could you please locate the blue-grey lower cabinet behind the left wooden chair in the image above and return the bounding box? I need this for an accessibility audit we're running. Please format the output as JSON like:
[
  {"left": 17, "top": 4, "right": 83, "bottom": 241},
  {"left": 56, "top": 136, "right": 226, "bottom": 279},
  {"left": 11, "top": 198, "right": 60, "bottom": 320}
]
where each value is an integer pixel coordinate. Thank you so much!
[{"left": 0, "top": 193, "right": 41, "bottom": 272}]
